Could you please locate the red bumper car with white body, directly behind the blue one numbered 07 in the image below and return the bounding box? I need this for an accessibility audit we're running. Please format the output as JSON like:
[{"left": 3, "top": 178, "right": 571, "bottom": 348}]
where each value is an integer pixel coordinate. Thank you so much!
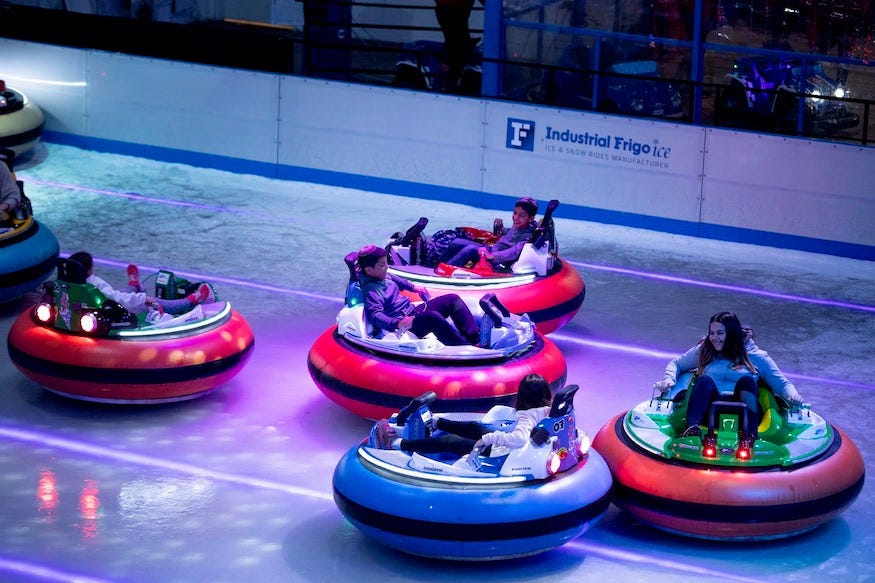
[{"left": 307, "top": 253, "right": 567, "bottom": 419}]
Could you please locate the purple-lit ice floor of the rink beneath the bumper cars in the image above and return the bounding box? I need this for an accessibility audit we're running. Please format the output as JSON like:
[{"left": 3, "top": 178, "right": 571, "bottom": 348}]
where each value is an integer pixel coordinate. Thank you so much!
[{"left": 0, "top": 144, "right": 875, "bottom": 583}]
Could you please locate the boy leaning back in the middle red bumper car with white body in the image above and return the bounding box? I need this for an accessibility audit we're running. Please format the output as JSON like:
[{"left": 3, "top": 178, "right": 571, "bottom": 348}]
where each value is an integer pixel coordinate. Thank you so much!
[{"left": 356, "top": 245, "right": 480, "bottom": 346}]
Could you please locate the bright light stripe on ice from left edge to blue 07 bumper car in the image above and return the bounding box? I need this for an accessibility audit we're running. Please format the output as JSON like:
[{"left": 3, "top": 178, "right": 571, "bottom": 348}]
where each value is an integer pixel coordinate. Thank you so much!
[{"left": 0, "top": 425, "right": 334, "bottom": 501}]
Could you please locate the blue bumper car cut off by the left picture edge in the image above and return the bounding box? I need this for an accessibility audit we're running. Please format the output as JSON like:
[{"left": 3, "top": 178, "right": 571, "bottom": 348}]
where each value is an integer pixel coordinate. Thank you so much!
[{"left": 0, "top": 162, "right": 60, "bottom": 302}]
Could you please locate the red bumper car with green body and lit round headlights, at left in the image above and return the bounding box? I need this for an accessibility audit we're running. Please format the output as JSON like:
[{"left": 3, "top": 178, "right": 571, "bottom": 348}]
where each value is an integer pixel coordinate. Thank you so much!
[{"left": 8, "top": 259, "right": 254, "bottom": 404}]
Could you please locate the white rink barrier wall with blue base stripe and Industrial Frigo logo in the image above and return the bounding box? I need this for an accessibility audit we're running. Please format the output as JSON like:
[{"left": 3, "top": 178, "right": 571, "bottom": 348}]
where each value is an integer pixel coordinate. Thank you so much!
[{"left": 0, "top": 39, "right": 875, "bottom": 260}]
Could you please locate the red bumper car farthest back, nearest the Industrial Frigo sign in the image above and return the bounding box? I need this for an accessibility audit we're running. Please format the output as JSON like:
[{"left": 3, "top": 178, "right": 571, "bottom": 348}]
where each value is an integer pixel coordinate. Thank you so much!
[{"left": 387, "top": 200, "right": 586, "bottom": 334}]
